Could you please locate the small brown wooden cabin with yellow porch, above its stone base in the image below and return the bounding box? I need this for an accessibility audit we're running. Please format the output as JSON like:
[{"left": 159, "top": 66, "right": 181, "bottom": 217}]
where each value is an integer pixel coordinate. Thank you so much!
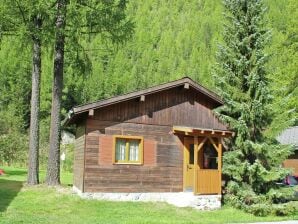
[{"left": 67, "top": 77, "right": 232, "bottom": 195}]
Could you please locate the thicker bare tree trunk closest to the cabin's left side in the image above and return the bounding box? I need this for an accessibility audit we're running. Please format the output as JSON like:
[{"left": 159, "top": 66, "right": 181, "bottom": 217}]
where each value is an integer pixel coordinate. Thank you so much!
[{"left": 46, "top": 0, "right": 66, "bottom": 185}]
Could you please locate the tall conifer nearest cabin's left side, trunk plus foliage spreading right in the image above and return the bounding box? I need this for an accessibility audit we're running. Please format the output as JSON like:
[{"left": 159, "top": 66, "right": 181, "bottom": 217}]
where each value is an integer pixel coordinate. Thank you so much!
[{"left": 46, "top": 0, "right": 132, "bottom": 185}]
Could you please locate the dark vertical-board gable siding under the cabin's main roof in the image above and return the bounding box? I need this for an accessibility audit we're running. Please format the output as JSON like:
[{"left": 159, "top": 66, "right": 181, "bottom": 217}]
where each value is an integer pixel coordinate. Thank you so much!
[{"left": 94, "top": 87, "right": 227, "bottom": 130}]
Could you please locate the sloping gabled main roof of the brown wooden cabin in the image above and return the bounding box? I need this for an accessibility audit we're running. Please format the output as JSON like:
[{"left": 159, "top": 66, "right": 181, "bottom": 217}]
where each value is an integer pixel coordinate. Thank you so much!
[{"left": 65, "top": 77, "right": 223, "bottom": 125}]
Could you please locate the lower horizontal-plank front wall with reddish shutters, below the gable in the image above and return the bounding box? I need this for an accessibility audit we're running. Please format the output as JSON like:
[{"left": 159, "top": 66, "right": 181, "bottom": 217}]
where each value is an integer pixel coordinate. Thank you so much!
[{"left": 84, "top": 121, "right": 183, "bottom": 192}]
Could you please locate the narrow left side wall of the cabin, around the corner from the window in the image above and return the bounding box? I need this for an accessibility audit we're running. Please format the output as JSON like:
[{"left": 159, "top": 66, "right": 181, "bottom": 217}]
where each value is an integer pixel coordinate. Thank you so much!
[{"left": 73, "top": 123, "right": 85, "bottom": 191}]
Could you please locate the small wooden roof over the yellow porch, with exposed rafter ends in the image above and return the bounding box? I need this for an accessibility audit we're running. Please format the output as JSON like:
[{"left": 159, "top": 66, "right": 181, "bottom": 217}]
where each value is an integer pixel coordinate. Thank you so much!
[{"left": 173, "top": 126, "right": 234, "bottom": 138}]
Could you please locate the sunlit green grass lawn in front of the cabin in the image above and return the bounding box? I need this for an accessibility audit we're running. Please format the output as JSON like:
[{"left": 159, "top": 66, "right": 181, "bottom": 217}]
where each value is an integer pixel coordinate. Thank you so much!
[{"left": 0, "top": 167, "right": 298, "bottom": 224}]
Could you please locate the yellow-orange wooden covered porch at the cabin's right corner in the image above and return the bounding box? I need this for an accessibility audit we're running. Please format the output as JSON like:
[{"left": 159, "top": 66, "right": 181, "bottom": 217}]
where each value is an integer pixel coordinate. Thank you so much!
[{"left": 173, "top": 126, "right": 233, "bottom": 195}]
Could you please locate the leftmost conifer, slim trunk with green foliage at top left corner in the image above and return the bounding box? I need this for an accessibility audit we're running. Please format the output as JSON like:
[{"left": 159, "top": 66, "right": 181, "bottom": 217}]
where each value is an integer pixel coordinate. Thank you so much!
[{"left": 0, "top": 0, "right": 48, "bottom": 185}]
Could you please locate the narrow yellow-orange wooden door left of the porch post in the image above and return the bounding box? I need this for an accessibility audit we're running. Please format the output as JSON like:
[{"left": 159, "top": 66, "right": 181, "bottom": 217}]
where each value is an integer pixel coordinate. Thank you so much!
[{"left": 183, "top": 138, "right": 195, "bottom": 192}]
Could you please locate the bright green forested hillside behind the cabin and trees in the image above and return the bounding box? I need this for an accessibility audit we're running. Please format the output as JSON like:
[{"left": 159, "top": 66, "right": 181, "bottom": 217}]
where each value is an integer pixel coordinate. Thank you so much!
[{"left": 0, "top": 0, "right": 298, "bottom": 169}]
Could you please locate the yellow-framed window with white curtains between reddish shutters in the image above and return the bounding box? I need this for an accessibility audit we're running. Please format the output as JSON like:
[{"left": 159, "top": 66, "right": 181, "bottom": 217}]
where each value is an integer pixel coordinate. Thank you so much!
[{"left": 114, "top": 136, "right": 143, "bottom": 164}]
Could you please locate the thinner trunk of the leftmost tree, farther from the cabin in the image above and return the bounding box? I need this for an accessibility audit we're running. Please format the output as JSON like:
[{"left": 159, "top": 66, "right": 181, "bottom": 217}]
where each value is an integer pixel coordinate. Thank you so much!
[{"left": 27, "top": 15, "right": 42, "bottom": 185}]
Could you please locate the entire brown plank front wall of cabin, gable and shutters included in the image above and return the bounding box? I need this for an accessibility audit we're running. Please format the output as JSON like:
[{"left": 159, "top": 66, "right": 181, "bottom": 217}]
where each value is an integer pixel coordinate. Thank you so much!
[{"left": 79, "top": 87, "right": 226, "bottom": 192}]
